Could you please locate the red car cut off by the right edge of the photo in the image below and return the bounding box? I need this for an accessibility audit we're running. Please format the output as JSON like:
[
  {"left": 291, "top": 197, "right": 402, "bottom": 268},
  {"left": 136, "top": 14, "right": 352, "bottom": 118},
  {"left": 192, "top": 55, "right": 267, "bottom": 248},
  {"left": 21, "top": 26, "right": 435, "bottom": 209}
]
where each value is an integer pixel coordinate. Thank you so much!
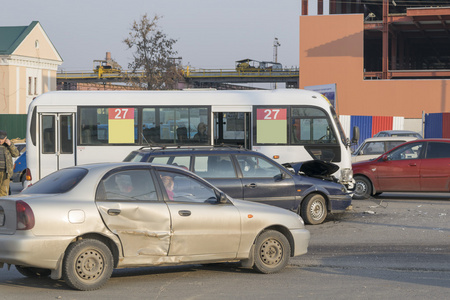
[{"left": 353, "top": 139, "right": 450, "bottom": 199}]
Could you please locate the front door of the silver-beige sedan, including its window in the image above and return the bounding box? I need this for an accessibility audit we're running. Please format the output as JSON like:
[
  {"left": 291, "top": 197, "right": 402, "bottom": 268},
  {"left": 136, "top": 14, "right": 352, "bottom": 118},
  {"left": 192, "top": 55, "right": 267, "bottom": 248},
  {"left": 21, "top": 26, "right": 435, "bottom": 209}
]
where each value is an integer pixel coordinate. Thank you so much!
[{"left": 157, "top": 167, "right": 241, "bottom": 261}]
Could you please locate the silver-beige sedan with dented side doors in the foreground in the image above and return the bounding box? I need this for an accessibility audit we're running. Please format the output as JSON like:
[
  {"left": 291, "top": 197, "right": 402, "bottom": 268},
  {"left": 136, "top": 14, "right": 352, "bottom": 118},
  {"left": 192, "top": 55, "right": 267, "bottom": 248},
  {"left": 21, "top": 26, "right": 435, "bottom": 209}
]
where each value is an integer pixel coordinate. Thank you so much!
[{"left": 0, "top": 163, "right": 310, "bottom": 290}]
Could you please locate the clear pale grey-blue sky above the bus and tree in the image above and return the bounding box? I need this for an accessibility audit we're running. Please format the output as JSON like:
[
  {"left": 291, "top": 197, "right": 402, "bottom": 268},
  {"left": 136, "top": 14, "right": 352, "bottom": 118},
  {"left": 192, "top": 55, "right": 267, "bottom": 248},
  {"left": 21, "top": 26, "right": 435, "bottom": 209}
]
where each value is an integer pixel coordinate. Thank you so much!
[{"left": 0, "top": 0, "right": 301, "bottom": 71}]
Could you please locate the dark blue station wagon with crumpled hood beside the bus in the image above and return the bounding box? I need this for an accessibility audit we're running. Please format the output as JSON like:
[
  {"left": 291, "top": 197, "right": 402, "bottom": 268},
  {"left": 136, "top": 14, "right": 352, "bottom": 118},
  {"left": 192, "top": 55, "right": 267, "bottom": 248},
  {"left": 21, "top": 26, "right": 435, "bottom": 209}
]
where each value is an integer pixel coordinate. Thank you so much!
[{"left": 124, "top": 146, "right": 352, "bottom": 224}]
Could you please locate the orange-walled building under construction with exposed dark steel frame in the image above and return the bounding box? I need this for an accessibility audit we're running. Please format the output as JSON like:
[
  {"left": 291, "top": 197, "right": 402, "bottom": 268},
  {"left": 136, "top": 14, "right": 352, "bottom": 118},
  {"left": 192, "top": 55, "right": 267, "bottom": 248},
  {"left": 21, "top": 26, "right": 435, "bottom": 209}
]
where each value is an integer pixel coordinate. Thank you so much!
[{"left": 299, "top": 0, "right": 450, "bottom": 132}]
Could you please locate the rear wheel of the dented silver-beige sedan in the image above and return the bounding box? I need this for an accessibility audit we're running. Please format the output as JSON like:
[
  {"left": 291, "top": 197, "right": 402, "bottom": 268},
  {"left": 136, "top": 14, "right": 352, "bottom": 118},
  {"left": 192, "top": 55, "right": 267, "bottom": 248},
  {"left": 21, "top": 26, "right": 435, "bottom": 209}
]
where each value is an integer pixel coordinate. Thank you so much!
[{"left": 63, "top": 239, "right": 114, "bottom": 291}]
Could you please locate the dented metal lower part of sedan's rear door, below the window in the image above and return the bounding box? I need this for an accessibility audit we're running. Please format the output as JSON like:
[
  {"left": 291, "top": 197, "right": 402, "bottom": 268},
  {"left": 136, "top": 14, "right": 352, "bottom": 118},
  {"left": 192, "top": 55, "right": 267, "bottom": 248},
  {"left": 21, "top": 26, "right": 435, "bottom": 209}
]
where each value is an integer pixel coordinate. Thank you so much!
[{"left": 97, "top": 201, "right": 171, "bottom": 260}]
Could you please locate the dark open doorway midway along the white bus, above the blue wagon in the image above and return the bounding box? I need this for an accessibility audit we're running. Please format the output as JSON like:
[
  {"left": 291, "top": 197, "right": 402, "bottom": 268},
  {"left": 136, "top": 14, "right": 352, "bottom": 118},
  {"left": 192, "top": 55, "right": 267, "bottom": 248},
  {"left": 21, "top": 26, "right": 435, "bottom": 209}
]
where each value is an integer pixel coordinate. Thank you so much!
[{"left": 214, "top": 112, "right": 251, "bottom": 149}]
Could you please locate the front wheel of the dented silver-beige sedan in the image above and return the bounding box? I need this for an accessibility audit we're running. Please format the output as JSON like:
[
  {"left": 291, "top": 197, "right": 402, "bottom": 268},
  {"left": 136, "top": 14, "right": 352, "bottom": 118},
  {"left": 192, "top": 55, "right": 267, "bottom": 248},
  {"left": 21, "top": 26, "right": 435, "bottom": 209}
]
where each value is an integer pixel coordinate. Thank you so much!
[{"left": 253, "top": 230, "right": 291, "bottom": 274}]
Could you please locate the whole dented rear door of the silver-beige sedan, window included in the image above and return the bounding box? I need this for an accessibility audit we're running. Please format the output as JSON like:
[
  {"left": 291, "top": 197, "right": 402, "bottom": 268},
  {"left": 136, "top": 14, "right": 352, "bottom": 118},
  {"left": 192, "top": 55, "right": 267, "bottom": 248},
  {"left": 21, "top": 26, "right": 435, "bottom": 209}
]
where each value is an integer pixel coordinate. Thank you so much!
[{"left": 95, "top": 168, "right": 171, "bottom": 263}]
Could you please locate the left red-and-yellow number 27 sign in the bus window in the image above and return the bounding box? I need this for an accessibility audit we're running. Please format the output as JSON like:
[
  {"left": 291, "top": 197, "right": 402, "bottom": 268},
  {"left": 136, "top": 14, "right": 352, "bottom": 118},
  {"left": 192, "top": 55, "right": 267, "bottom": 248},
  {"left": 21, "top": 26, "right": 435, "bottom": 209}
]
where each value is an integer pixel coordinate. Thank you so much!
[{"left": 108, "top": 107, "right": 134, "bottom": 144}]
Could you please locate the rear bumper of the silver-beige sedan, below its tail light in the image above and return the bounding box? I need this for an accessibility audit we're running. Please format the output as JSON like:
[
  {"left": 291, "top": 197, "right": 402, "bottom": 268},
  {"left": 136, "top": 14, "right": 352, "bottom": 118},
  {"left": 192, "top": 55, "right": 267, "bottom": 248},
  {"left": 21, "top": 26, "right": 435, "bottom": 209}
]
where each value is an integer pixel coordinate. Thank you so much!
[{"left": 0, "top": 231, "right": 74, "bottom": 269}]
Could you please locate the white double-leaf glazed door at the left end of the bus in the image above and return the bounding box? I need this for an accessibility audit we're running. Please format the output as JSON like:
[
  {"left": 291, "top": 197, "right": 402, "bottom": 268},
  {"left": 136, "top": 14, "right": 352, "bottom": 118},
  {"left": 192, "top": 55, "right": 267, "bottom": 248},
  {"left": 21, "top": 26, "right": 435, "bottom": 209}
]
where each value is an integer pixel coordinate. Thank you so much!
[{"left": 39, "top": 113, "right": 75, "bottom": 179}]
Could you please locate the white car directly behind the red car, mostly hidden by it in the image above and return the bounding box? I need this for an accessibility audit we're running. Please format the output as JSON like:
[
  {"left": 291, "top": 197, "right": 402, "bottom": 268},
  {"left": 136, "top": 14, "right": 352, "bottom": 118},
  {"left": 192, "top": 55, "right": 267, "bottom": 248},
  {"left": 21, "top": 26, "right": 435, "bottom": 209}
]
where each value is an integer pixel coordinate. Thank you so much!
[{"left": 352, "top": 136, "right": 417, "bottom": 163}]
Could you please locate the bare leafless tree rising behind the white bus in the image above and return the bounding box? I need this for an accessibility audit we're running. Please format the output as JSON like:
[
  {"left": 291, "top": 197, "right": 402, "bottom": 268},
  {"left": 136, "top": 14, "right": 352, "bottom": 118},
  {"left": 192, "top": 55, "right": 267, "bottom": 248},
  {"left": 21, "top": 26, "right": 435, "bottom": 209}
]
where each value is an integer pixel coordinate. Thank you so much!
[{"left": 123, "top": 14, "right": 182, "bottom": 90}]
